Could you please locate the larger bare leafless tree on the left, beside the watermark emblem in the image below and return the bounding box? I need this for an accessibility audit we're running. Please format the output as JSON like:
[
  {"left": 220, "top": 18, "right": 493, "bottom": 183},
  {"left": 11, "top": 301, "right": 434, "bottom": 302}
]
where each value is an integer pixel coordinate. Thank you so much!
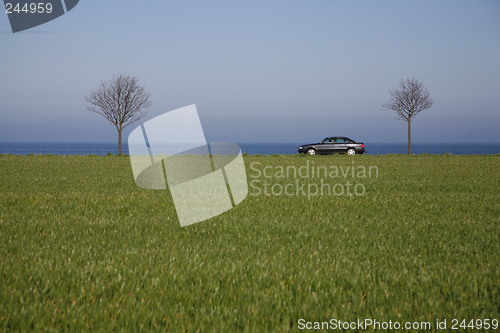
[{"left": 84, "top": 74, "right": 152, "bottom": 154}]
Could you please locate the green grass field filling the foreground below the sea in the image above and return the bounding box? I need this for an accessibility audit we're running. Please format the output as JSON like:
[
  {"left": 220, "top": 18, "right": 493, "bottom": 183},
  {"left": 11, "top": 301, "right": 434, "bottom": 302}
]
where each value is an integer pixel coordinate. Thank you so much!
[{"left": 0, "top": 155, "right": 500, "bottom": 332}]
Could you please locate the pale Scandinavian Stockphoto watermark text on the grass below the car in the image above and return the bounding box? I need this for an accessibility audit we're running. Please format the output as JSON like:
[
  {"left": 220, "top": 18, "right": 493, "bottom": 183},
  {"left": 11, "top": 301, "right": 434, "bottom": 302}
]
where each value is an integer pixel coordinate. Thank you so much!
[{"left": 249, "top": 160, "right": 379, "bottom": 200}]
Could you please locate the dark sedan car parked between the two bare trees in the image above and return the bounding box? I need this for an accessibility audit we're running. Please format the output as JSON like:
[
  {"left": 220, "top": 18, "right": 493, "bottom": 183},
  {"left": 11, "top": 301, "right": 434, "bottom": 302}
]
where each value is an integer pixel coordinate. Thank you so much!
[{"left": 299, "top": 136, "right": 366, "bottom": 155}]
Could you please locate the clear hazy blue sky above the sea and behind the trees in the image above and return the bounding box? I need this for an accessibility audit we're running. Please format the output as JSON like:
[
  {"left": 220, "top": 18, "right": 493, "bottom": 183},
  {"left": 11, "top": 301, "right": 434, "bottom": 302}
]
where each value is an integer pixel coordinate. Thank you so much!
[{"left": 0, "top": 0, "right": 500, "bottom": 143}]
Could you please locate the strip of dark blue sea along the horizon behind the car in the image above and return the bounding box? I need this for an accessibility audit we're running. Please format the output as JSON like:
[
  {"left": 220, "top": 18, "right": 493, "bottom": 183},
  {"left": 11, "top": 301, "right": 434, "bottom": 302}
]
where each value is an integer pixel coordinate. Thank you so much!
[{"left": 0, "top": 142, "right": 500, "bottom": 155}]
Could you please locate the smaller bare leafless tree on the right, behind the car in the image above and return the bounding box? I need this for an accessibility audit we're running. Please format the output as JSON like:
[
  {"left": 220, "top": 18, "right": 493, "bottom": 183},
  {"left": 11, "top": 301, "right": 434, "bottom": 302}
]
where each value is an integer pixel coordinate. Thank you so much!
[{"left": 382, "top": 77, "right": 434, "bottom": 155}]
